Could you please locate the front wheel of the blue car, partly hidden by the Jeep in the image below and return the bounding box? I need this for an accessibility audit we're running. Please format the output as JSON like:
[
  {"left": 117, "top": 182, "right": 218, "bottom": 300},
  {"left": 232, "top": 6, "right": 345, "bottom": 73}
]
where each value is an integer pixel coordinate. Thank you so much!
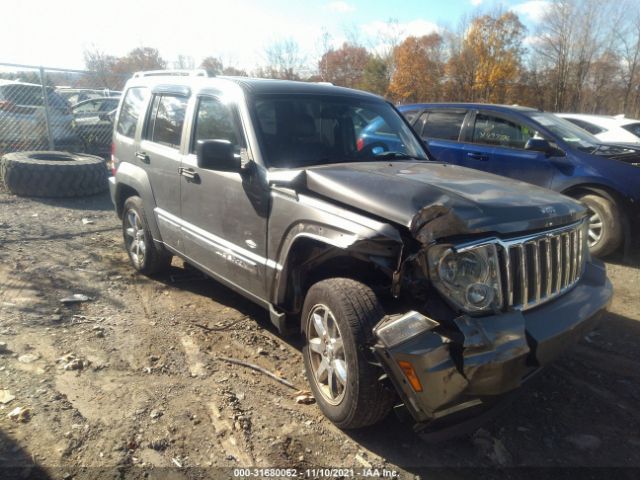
[{"left": 578, "top": 193, "right": 624, "bottom": 257}]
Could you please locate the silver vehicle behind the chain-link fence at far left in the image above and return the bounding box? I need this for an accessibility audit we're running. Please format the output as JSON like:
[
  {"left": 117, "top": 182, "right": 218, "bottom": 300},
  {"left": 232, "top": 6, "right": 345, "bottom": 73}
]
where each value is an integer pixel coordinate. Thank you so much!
[{"left": 0, "top": 80, "right": 84, "bottom": 152}]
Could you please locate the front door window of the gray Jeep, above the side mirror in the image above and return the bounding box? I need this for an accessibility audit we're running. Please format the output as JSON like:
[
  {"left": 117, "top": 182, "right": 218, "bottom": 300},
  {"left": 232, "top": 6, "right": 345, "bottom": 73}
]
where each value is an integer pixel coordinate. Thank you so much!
[{"left": 191, "top": 97, "right": 244, "bottom": 153}]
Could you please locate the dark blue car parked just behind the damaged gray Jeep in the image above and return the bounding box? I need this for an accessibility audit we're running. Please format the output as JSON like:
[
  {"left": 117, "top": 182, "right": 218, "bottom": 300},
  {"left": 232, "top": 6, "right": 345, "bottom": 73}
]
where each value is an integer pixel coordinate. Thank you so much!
[{"left": 399, "top": 103, "right": 640, "bottom": 256}]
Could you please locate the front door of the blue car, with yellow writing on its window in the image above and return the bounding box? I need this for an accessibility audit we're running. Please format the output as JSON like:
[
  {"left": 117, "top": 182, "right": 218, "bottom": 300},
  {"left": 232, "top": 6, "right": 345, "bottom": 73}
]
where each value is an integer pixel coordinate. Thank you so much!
[{"left": 468, "top": 110, "right": 555, "bottom": 187}]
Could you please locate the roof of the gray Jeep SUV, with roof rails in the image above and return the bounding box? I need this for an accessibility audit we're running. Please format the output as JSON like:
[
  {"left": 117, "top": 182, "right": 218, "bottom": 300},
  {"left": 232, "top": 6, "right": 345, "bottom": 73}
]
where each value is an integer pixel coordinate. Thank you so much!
[{"left": 129, "top": 75, "right": 383, "bottom": 100}]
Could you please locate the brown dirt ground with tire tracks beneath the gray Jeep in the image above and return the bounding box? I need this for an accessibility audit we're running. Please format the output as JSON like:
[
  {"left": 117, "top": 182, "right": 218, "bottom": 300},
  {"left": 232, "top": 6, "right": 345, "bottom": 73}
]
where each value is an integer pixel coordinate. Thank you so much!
[{"left": 0, "top": 186, "right": 640, "bottom": 479}]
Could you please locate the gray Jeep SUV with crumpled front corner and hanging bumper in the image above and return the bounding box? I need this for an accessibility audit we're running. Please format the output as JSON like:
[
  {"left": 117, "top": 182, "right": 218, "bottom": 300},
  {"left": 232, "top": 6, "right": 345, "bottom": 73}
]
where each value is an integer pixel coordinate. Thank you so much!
[{"left": 110, "top": 73, "right": 612, "bottom": 429}]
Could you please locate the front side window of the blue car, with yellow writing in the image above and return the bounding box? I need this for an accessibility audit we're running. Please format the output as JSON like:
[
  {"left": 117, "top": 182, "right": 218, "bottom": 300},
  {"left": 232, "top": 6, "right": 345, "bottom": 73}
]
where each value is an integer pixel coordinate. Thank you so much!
[{"left": 473, "top": 113, "right": 539, "bottom": 149}]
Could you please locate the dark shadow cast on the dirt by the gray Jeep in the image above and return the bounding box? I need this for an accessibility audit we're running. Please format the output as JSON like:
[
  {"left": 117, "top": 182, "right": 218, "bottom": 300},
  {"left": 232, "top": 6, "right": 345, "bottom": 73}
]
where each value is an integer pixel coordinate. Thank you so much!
[{"left": 144, "top": 267, "right": 640, "bottom": 472}]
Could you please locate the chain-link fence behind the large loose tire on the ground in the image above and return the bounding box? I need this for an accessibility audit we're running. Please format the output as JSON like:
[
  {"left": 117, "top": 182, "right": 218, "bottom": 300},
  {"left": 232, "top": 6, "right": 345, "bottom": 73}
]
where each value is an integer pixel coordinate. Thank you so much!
[{"left": 0, "top": 63, "right": 128, "bottom": 158}]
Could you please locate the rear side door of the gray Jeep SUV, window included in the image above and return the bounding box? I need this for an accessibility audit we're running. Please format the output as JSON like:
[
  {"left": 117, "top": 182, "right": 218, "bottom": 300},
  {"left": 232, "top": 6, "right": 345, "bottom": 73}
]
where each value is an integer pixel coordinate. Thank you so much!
[{"left": 139, "top": 90, "right": 189, "bottom": 252}]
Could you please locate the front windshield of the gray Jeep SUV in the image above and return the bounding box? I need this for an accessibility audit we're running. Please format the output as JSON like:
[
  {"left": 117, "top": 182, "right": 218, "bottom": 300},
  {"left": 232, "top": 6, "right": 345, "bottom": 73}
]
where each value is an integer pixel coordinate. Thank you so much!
[{"left": 252, "top": 94, "right": 428, "bottom": 168}]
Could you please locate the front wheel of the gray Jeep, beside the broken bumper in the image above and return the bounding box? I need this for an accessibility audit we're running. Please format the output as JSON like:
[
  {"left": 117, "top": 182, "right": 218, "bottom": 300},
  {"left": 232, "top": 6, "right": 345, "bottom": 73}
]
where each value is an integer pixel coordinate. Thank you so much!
[{"left": 302, "top": 278, "right": 395, "bottom": 429}]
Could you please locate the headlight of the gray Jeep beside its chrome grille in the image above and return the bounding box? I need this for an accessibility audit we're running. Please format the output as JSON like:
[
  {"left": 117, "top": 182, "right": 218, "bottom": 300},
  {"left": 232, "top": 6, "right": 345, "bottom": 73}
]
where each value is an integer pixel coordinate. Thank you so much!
[{"left": 427, "top": 244, "right": 502, "bottom": 313}]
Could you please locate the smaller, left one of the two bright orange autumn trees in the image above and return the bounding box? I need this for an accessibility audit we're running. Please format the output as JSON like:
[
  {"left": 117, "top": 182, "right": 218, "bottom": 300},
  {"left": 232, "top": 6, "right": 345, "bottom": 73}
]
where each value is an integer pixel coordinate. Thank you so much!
[{"left": 388, "top": 33, "right": 444, "bottom": 103}]
